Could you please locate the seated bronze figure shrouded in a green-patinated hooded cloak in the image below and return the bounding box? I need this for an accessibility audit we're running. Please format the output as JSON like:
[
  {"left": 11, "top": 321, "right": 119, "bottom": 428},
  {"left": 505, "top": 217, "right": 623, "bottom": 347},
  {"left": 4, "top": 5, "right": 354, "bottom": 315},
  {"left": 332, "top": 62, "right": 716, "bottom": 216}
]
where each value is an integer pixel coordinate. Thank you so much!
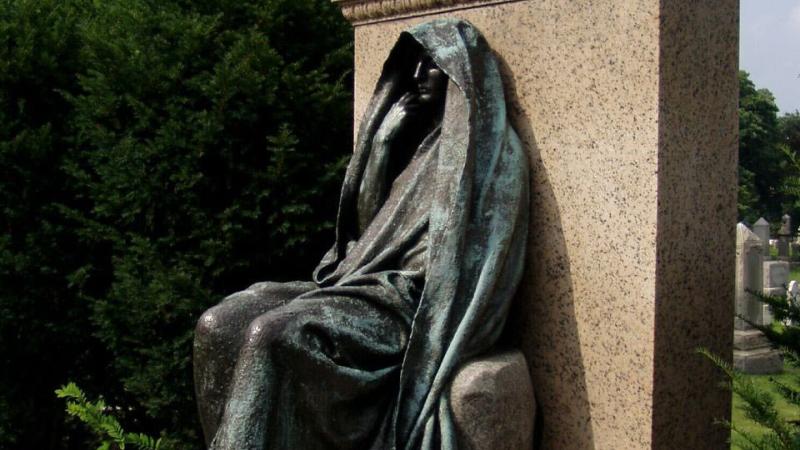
[{"left": 194, "top": 20, "right": 528, "bottom": 450}]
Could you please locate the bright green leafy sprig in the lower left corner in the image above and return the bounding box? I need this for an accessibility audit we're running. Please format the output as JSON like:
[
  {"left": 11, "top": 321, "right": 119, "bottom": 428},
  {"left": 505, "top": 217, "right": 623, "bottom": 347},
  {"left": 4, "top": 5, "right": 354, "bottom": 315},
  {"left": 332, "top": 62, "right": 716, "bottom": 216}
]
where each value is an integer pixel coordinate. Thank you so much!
[{"left": 56, "top": 383, "right": 167, "bottom": 450}]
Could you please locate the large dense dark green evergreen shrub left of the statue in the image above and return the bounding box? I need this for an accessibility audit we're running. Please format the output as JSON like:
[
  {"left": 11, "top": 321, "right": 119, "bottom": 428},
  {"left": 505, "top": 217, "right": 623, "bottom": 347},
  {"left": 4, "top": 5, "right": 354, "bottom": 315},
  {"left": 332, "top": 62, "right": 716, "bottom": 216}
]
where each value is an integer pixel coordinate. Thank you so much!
[{"left": 0, "top": 0, "right": 352, "bottom": 449}]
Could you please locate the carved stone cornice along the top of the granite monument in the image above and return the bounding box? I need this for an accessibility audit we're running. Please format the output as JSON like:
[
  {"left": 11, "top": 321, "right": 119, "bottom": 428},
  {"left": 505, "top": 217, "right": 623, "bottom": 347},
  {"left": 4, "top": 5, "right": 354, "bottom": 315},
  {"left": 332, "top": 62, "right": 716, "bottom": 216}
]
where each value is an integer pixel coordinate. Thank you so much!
[{"left": 332, "top": 0, "right": 513, "bottom": 24}]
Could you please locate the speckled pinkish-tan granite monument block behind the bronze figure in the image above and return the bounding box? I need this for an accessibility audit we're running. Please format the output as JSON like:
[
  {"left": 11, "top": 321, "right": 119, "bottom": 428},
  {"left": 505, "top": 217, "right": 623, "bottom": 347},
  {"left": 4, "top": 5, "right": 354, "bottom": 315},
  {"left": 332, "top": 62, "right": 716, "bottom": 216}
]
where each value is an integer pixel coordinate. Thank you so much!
[{"left": 332, "top": 0, "right": 738, "bottom": 450}]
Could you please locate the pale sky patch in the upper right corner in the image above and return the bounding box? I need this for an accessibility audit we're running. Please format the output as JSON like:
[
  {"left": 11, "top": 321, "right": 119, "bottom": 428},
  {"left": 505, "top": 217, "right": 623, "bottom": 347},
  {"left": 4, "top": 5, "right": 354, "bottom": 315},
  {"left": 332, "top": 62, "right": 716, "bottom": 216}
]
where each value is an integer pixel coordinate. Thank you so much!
[{"left": 739, "top": 0, "right": 800, "bottom": 115}]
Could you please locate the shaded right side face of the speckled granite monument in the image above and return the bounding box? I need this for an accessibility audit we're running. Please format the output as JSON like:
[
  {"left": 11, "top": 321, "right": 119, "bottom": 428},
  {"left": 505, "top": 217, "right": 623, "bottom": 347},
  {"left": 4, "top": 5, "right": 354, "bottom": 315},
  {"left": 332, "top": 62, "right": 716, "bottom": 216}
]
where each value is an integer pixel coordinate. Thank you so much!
[{"left": 652, "top": 0, "right": 739, "bottom": 449}]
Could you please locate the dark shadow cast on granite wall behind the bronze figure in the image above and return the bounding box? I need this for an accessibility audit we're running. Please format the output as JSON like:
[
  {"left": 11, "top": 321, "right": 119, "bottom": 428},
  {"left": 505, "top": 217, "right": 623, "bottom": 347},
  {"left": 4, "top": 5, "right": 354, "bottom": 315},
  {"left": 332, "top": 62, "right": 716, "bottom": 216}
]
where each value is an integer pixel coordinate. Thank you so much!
[{"left": 496, "top": 55, "right": 595, "bottom": 449}]
